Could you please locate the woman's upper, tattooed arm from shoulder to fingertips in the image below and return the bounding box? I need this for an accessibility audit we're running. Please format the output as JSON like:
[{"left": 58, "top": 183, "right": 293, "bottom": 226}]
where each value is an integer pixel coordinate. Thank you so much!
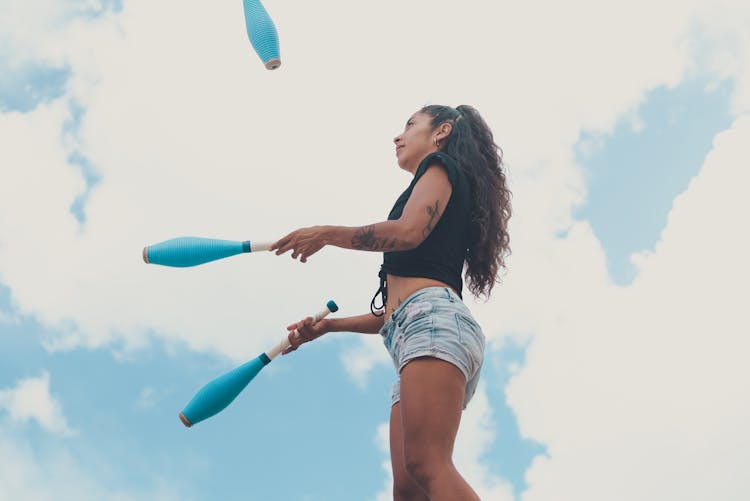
[{"left": 271, "top": 166, "right": 452, "bottom": 263}]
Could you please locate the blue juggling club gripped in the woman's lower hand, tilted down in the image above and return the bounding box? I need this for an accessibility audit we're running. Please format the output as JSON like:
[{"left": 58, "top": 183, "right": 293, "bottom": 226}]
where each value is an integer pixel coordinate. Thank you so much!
[{"left": 180, "top": 301, "right": 339, "bottom": 428}]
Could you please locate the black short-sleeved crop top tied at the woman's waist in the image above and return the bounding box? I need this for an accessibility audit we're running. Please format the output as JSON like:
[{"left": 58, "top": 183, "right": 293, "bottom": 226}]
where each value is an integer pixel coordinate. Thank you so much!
[{"left": 370, "top": 152, "right": 471, "bottom": 314}]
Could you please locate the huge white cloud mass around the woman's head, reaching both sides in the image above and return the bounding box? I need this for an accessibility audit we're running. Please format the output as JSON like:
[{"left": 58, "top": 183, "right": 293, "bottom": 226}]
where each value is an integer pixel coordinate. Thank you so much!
[{"left": 0, "top": 0, "right": 750, "bottom": 500}]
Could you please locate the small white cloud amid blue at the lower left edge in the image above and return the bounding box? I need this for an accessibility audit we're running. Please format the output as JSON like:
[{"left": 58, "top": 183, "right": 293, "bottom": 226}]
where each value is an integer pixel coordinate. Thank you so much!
[{"left": 0, "top": 372, "right": 77, "bottom": 436}]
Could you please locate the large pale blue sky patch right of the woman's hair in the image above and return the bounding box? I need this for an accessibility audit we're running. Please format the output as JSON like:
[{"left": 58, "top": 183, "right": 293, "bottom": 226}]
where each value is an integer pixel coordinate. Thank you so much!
[{"left": 574, "top": 79, "right": 732, "bottom": 285}]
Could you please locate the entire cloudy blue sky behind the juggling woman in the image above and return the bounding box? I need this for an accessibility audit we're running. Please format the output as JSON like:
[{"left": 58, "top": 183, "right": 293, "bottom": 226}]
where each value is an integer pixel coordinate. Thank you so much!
[{"left": 0, "top": 0, "right": 750, "bottom": 501}]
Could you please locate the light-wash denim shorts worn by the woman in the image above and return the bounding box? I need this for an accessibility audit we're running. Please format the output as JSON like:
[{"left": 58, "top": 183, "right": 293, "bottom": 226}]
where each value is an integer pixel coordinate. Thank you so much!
[{"left": 380, "top": 287, "right": 484, "bottom": 409}]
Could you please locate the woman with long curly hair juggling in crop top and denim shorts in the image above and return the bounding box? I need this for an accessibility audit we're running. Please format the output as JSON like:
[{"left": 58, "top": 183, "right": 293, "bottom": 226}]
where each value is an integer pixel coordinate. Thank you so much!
[{"left": 272, "top": 105, "right": 511, "bottom": 501}]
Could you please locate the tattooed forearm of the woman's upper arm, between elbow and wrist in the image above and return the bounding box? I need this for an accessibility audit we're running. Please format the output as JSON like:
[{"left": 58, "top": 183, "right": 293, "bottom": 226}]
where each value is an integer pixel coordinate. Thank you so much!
[{"left": 324, "top": 220, "right": 421, "bottom": 252}]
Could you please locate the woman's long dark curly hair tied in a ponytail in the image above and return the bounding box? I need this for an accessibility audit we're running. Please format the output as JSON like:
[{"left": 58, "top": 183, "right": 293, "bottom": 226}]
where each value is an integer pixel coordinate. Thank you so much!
[{"left": 420, "top": 104, "right": 512, "bottom": 298}]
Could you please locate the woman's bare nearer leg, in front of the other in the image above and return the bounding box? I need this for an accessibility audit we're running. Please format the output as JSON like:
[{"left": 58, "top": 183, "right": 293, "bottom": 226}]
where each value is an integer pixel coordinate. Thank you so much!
[{"left": 400, "top": 357, "right": 479, "bottom": 501}]
